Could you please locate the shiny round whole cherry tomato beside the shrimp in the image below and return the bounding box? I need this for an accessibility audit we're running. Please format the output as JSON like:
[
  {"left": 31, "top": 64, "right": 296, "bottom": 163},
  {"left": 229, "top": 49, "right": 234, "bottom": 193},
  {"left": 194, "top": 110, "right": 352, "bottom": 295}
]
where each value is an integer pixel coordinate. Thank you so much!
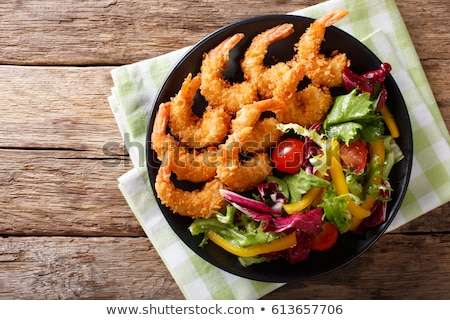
[{"left": 272, "top": 138, "right": 304, "bottom": 173}]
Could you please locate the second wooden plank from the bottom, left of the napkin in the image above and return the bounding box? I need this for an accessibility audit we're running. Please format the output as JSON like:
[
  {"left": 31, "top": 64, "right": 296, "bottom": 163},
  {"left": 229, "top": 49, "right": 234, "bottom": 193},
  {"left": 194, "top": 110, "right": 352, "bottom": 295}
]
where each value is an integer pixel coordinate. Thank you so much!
[{"left": 0, "top": 149, "right": 143, "bottom": 236}]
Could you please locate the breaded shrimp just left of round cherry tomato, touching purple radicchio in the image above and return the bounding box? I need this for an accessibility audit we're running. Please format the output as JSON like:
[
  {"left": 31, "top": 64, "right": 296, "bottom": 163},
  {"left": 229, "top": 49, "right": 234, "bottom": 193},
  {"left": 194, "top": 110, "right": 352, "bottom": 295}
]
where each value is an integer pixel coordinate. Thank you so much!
[{"left": 217, "top": 127, "right": 272, "bottom": 192}]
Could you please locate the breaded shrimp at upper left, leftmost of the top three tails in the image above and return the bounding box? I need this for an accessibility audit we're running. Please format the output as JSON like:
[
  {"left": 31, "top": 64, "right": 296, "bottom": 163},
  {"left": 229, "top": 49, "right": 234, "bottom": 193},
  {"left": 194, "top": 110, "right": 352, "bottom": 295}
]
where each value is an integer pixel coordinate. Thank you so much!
[{"left": 200, "top": 33, "right": 258, "bottom": 114}]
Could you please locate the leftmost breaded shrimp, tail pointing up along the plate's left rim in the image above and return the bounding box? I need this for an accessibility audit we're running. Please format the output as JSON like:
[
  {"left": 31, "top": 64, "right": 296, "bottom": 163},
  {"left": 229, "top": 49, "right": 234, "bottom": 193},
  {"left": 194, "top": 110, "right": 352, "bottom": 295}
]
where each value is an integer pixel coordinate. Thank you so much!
[{"left": 150, "top": 102, "right": 217, "bottom": 182}]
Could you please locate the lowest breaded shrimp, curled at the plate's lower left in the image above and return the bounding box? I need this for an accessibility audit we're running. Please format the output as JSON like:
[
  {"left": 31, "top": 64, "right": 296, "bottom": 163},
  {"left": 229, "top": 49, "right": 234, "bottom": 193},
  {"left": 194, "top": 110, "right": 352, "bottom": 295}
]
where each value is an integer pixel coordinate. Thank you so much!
[{"left": 155, "top": 166, "right": 225, "bottom": 219}]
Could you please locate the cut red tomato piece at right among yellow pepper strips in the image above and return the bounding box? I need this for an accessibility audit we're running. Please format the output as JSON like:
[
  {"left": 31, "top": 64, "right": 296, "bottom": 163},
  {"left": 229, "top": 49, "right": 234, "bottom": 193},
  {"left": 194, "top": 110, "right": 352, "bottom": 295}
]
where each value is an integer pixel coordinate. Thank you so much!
[{"left": 339, "top": 140, "right": 368, "bottom": 173}]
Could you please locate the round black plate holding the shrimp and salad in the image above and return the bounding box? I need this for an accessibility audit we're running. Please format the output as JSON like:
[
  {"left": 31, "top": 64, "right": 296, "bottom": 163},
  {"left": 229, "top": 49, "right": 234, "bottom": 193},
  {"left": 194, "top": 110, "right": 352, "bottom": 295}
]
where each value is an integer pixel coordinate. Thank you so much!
[{"left": 146, "top": 15, "right": 412, "bottom": 282}]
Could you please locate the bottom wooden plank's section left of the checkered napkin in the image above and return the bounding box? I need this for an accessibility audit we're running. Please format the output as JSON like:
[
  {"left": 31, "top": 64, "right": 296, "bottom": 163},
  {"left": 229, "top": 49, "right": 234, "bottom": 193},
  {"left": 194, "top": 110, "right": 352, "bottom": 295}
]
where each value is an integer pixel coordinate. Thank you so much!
[{"left": 0, "top": 237, "right": 183, "bottom": 299}]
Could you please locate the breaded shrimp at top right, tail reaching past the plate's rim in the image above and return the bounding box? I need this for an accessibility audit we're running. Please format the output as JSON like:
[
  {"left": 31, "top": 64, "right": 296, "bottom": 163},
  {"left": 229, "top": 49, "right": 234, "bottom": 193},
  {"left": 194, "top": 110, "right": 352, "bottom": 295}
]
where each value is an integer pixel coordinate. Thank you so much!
[{"left": 295, "top": 9, "right": 349, "bottom": 87}]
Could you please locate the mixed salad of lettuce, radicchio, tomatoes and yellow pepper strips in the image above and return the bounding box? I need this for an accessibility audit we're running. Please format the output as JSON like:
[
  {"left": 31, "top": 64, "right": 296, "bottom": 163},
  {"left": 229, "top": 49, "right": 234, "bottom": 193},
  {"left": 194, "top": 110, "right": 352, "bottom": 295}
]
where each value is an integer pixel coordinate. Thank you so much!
[{"left": 189, "top": 63, "right": 403, "bottom": 266}]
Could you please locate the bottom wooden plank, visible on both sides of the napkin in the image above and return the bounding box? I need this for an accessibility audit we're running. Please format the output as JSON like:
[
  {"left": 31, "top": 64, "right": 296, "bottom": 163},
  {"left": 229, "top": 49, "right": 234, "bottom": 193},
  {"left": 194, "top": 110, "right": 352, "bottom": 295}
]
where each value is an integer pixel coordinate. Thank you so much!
[{"left": 0, "top": 234, "right": 450, "bottom": 300}]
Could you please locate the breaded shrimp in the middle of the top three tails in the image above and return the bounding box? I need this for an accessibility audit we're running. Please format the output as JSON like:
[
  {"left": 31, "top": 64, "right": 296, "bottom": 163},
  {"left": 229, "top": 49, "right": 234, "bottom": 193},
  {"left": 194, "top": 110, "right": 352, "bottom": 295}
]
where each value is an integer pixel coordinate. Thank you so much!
[{"left": 241, "top": 23, "right": 294, "bottom": 98}]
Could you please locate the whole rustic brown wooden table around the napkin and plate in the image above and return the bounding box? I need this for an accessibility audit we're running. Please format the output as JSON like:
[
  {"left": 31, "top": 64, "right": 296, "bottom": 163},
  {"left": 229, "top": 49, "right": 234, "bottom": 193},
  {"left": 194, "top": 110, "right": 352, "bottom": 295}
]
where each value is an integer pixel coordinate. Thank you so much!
[{"left": 0, "top": 0, "right": 450, "bottom": 299}]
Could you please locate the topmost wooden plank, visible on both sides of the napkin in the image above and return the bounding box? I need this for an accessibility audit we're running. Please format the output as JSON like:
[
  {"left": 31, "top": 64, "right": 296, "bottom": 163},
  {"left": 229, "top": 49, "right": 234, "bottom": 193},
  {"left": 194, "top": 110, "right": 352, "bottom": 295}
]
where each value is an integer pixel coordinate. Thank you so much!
[{"left": 0, "top": 0, "right": 450, "bottom": 65}]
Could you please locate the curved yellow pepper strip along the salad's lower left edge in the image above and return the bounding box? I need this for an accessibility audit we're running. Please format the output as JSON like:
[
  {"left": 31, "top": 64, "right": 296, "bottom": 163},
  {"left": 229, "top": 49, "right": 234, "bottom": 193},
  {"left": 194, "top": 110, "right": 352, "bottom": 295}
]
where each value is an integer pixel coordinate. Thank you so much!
[{"left": 206, "top": 230, "right": 297, "bottom": 257}]
